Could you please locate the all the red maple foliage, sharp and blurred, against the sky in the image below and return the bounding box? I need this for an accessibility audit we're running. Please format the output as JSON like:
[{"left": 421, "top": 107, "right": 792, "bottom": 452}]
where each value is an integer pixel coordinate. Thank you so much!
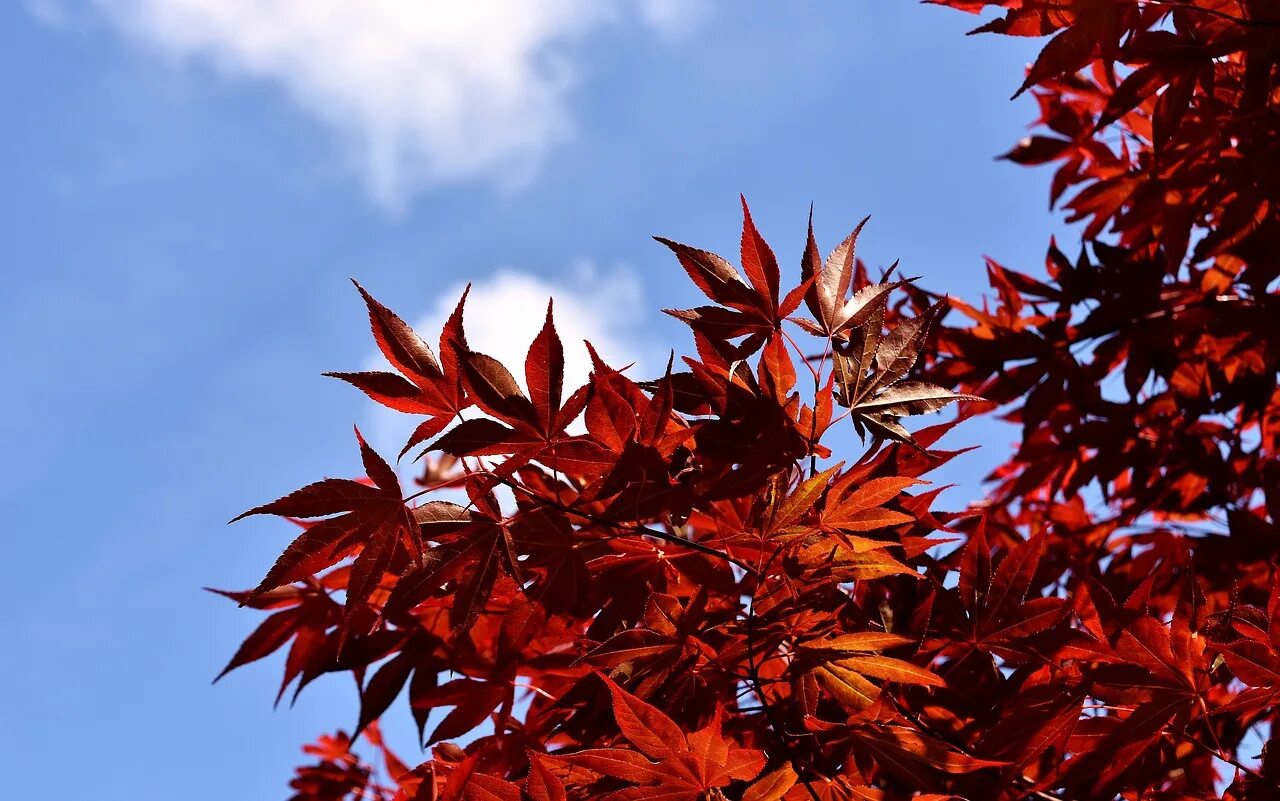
[{"left": 227, "top": 0, "right": 1280, "bottom": 801}]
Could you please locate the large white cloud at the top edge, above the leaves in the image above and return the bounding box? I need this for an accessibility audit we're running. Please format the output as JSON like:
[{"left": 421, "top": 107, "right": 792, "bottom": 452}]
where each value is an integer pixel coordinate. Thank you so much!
[{"left": 90, "top": 0, "right": 708, "bottom": 210}]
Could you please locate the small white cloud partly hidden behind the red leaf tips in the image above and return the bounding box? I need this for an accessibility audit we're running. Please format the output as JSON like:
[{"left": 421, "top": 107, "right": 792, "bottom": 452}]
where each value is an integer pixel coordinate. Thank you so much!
[{"left": 361, "top": 264, "right": 664, "bottom": 460}]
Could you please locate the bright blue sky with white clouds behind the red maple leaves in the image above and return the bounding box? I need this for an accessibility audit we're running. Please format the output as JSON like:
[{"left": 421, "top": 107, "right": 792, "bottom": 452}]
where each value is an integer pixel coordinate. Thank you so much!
[{"left": 0, "top": 0, "right": 1061, "bottom": 800}]
